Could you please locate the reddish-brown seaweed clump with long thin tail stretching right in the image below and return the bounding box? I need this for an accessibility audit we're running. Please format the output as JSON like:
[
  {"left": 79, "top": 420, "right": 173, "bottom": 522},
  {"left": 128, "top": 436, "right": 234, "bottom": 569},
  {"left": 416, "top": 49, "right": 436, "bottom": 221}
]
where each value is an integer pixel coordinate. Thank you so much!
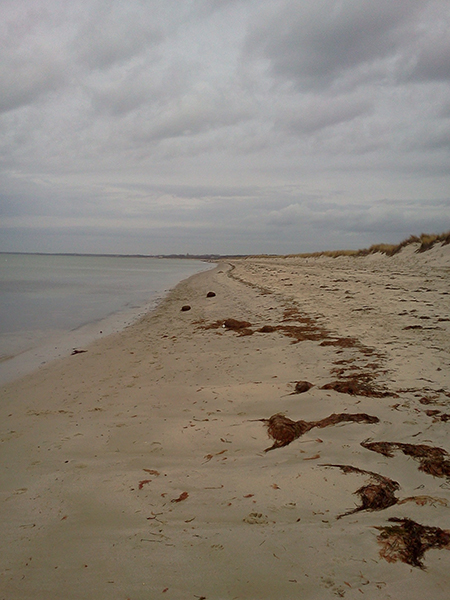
[{"left": 258, "top": 413, "right": 379, "bottom": 452}]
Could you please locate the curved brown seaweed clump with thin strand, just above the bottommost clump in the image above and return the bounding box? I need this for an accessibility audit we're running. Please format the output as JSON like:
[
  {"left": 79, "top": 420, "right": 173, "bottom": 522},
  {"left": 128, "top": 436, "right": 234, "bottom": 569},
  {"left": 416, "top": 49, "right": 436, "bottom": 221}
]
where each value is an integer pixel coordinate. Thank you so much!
[{"left": 320, "top": 464, "right": 400, "bottom": 519}]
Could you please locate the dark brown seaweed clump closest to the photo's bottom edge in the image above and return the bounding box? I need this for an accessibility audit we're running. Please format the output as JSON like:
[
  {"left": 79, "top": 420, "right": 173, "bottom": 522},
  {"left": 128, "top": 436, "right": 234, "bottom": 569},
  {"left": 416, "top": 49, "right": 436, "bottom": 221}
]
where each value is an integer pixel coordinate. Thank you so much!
[{"left": 376, "top": 517, "right": 450, "bottom": 569}]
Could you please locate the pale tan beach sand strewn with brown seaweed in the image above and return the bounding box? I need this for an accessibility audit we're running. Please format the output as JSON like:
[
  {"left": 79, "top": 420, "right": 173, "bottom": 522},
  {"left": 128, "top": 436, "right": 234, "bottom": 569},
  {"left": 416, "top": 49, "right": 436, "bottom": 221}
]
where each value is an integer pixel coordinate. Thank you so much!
[{"left": 0, "top": 245, "right": 450, "bottom": 600}]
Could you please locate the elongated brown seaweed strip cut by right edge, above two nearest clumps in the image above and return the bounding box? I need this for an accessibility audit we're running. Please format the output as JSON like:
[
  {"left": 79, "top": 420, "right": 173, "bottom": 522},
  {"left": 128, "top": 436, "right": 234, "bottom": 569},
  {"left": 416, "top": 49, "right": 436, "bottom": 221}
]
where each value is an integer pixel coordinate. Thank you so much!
[{"left": 361, "top": 440, "right": 450, "bottom": 477}]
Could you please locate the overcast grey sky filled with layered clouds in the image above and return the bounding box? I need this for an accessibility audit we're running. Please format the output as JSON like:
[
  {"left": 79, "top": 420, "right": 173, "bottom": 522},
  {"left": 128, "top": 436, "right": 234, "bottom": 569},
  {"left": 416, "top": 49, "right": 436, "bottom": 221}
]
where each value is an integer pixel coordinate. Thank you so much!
[{"left": 0, "top": 0, "right": 450, "bottom": 254}]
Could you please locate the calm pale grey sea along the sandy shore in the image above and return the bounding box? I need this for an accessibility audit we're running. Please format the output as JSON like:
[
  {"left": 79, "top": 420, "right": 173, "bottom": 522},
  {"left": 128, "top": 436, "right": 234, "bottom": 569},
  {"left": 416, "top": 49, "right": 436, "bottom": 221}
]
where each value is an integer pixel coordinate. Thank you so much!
[{"left": 0, "top": 253, "right": 214, "bottom": 383}]
